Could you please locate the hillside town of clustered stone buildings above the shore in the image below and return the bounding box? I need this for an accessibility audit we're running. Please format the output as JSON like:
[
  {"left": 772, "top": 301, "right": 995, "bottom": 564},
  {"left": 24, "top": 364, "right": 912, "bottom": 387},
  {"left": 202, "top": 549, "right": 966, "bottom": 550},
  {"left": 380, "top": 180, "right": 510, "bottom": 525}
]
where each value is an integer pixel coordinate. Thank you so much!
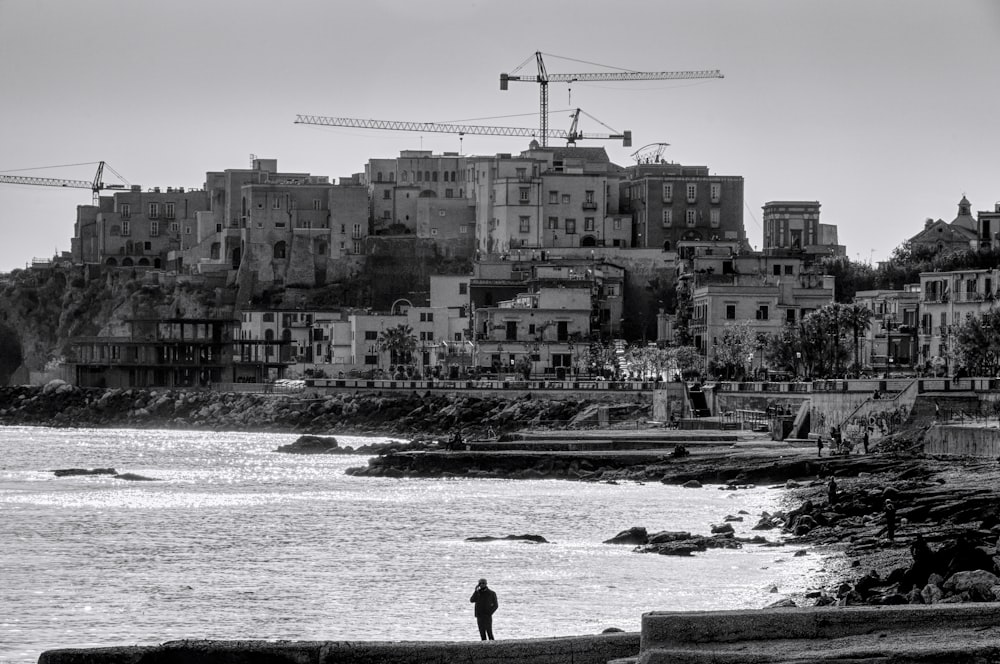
[{"left": 1, "top": 141, "right": 1000, "bottom": 388}]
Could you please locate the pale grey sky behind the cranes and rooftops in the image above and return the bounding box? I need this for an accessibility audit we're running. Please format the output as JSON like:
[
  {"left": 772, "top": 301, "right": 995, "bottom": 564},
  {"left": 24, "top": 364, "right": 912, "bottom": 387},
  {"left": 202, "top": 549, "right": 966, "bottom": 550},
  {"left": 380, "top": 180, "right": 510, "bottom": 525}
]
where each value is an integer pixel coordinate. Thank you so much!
[{"left": 0, "top": 0, "right": 1000, "bottom": 272}]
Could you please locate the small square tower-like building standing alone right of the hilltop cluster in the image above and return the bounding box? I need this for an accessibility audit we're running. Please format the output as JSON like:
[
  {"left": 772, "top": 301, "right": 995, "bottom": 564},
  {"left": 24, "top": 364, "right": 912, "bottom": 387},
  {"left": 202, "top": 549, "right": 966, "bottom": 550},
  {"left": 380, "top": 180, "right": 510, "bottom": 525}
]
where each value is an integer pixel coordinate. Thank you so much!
[{"left": 763, "top": 201, "right": 847, "bottom": 257}]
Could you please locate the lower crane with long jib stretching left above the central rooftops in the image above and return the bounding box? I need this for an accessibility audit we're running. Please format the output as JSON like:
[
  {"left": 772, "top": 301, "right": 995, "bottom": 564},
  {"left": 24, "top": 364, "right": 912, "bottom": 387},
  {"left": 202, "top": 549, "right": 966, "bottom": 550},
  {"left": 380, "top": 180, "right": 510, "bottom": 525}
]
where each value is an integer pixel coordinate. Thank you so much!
[{"left": 295, "top": 108, "right": 632, "bottom": 147}]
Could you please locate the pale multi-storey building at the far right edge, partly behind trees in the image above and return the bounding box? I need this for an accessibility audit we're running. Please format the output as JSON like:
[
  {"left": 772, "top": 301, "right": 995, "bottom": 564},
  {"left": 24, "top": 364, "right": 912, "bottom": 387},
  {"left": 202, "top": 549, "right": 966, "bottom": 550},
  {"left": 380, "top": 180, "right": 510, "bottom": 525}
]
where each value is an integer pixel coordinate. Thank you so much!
[{"left": 919, "top": 268, "right": 1000, "bottom": 374}]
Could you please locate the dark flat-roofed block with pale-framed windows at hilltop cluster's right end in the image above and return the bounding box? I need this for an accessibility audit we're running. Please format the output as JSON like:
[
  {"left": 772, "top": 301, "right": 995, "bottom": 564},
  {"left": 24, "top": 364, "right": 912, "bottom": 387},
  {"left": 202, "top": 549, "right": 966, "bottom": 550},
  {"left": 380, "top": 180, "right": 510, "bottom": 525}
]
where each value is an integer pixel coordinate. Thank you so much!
[{"left": 621, "top": 162, "right": 746, "bottom": 251}]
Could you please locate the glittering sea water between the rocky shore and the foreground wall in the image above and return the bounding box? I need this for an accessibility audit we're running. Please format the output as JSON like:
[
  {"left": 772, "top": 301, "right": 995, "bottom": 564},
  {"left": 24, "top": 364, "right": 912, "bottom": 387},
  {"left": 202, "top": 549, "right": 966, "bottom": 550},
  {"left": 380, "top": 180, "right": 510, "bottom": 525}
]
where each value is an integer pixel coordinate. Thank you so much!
[{"left": 0, "top": 427, "right": 831, "bottom": 664}]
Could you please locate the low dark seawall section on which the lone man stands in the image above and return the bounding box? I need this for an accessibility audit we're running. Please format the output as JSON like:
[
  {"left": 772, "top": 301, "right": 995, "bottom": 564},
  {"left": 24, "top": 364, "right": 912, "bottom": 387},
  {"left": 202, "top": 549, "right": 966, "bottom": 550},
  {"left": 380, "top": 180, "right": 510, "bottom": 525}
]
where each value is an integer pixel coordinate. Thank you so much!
[{"left": 38, "top": 632, "right": 639, "bottom": 664}]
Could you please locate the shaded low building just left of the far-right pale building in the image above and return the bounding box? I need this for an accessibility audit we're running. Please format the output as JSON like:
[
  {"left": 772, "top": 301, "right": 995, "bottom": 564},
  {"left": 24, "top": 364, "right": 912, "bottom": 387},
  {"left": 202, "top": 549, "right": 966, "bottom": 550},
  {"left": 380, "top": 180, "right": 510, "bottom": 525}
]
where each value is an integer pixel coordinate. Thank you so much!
[{"left": 854, "top": 284, "right": 921, "bottom": 374}]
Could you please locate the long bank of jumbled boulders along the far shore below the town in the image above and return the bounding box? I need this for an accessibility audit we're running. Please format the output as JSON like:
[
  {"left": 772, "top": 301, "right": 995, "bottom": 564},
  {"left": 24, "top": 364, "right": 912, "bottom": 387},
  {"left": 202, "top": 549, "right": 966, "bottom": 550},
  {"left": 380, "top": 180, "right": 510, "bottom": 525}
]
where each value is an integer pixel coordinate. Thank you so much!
[{"left": 0, "top": 381, "right": 649, "bottom": 436}]
